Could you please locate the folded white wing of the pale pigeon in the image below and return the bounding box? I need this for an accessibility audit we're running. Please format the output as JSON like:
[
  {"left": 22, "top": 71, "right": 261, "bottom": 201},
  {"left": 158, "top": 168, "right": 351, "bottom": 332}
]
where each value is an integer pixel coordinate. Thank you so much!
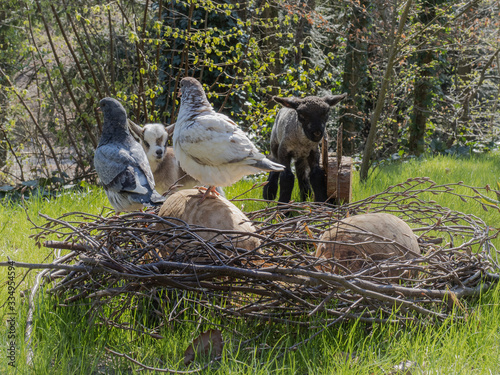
[{"left": 178, "top": 113, "right": 263, "bottom": 166}]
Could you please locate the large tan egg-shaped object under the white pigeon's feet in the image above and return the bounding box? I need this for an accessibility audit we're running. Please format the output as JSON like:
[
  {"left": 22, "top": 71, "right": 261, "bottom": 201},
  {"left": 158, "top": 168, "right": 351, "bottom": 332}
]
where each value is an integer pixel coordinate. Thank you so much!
[{"left": 159, "top": 189, "right": 260, "bottom": 254}]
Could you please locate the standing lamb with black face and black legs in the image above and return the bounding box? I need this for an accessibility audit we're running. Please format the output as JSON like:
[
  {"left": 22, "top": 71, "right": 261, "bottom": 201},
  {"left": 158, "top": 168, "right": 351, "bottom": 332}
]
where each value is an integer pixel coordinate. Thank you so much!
[{"left": 263, "top": 94, "right": 347, "bottom": 203}]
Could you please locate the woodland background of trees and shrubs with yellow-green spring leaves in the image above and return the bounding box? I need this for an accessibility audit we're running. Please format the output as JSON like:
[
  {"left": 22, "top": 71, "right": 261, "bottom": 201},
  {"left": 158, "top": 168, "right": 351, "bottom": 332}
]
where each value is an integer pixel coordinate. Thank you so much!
[{"left": 0, "top": 0, "right": 500, "bottom": 184}]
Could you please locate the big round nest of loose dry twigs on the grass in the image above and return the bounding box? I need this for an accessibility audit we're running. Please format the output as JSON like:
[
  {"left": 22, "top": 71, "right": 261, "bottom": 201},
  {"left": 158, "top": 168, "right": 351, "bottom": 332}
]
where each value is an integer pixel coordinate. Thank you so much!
[{"left": 16, "top": 178, "right": 500, "bottom": 325}]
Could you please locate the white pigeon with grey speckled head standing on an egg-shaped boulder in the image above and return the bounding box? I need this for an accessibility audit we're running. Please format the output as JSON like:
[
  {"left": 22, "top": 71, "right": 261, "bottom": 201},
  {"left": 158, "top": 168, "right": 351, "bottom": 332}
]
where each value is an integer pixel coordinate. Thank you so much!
[{"left": 172, "top": 77, "right": 285, "bottom": 201}]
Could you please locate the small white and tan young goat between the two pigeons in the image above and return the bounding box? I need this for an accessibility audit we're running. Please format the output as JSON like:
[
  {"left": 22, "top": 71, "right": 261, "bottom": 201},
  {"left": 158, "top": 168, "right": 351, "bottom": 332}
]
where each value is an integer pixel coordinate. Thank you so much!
[{"left": 129, "top": 121, "right": 199, "bottom": 194}]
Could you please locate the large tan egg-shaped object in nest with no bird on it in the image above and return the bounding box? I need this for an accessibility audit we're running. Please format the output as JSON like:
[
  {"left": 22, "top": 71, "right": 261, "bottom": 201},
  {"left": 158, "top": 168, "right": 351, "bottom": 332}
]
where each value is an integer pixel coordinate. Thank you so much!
[{"left": 316, "top": 213, "right": 420, "bottom": 277}]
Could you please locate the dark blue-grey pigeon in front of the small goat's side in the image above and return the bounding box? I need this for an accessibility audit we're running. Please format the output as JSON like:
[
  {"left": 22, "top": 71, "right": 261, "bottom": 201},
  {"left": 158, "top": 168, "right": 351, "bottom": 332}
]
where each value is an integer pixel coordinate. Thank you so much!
[{"left": 94, "top": 98, "right": 166, "bottom": 213}]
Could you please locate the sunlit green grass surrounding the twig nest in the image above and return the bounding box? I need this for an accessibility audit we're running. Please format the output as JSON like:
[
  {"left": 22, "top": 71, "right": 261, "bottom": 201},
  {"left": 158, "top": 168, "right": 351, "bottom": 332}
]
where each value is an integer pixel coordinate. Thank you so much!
[{"left": 0, "top": 154, "right": 500, "bottom": 375}]
